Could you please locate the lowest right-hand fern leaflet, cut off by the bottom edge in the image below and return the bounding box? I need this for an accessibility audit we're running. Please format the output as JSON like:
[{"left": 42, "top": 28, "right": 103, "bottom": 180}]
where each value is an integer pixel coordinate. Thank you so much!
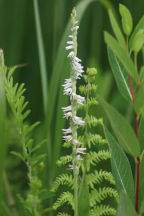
[{"left": 90, "top": 205, "right": 116, "bottom": 216}]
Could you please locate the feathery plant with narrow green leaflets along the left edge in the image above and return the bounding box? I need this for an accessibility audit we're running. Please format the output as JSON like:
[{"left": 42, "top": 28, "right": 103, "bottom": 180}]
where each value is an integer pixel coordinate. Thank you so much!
[{"left": 2, "top": 49, "right": 46, "bottom": 216}]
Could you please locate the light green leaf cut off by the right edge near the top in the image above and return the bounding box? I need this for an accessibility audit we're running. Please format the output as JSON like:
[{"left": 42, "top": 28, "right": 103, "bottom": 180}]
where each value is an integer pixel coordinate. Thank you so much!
[{"left": 131, "top": 29, "right": 144, "bottom": 54}]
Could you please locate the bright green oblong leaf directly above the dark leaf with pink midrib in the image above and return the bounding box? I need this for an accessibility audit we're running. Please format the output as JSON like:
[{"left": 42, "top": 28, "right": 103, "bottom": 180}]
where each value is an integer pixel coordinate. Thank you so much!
[{"left": 104, "top": 32, "right": 138, "bottom": 82}]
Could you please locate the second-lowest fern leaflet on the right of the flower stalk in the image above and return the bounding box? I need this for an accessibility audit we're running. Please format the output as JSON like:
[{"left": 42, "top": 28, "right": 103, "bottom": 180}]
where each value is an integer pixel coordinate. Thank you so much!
[{"left": 90, "top": 187, "right": 118, "bottom": 207}]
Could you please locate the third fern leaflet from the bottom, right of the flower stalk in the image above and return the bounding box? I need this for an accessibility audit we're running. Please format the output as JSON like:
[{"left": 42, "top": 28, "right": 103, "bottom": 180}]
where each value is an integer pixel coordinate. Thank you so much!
[{"left": 87, "top": 170, "right": 115, "bottom": 189}]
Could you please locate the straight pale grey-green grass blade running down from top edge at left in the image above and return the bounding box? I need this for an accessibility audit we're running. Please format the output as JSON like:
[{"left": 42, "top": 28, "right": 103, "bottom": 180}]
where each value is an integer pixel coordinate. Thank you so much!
[{"left": 33, "top": 0, "right": 48, "bottom": 114}]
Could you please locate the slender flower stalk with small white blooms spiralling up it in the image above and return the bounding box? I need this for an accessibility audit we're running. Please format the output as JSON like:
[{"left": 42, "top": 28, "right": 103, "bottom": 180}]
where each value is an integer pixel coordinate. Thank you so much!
[{"left": 62, "top": 8, "right": 86, "bottom": 216}]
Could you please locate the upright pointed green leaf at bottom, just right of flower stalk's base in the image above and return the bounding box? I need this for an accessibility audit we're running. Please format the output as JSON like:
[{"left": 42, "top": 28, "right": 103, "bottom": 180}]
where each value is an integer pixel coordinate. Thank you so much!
[{"left": 78, "top": 176, "right": 90, "bottom": 216}]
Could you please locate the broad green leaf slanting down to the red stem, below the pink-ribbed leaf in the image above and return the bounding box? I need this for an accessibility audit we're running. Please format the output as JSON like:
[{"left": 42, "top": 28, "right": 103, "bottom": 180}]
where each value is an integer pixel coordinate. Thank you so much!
[{"left": 99, "top": 97, "right": 140, "bottom": 158}]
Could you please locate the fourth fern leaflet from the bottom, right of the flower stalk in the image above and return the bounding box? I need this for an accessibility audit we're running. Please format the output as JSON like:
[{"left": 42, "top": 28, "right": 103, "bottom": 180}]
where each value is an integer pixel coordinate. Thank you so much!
[{"left": 87, "top": 150, "right": 111, "bottom": 167}]
